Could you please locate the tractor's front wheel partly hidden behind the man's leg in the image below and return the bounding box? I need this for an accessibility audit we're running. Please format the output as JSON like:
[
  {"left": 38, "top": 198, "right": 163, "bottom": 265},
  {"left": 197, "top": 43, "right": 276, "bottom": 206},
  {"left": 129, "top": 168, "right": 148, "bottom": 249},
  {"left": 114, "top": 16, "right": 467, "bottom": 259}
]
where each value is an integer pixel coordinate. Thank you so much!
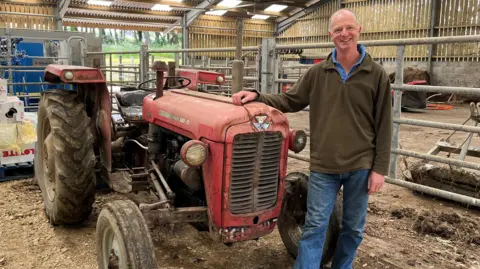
[{"left": 278, "top": 172, "right": 342, "bottom": 268}]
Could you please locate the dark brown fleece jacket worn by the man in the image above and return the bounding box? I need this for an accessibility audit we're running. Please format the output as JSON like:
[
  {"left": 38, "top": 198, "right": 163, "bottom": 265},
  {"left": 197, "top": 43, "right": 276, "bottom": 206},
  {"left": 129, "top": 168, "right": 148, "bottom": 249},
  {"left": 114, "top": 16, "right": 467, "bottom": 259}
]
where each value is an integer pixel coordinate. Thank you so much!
[{"left": 256, "top": 53, "right": 392, "bottom": 175}]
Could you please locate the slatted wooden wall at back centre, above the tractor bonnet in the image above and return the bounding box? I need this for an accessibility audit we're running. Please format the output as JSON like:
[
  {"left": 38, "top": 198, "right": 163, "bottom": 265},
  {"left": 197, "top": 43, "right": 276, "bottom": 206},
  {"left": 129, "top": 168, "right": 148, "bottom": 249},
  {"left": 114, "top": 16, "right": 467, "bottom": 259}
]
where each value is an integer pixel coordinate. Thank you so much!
[{"left": 188, "top": 15, "right": 275, "bottom": 59}]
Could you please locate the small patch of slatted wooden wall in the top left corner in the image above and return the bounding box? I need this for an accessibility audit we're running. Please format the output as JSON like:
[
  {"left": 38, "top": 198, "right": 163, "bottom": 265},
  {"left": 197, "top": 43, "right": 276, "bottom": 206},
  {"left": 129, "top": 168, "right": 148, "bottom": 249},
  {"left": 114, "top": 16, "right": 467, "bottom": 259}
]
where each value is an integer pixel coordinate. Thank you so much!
[{"left": 0, "top": 2, "right": 56, "bottom": 30}]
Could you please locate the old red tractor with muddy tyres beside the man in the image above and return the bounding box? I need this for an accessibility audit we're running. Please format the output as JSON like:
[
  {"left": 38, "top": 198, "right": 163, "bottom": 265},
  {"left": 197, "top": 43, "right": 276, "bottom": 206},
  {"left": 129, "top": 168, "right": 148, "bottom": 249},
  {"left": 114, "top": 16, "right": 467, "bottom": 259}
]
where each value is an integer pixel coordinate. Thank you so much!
[{"left": 35, "top": 62, "right": 341, "bottom": 269}]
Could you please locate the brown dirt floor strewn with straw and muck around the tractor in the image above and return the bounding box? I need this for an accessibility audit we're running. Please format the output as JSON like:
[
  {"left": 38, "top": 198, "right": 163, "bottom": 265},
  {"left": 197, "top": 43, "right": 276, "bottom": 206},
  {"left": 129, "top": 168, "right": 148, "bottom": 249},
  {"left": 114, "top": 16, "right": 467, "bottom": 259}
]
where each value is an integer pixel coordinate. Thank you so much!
[{"left": 0, "top": 103, "right": 480, "bottom": 269}]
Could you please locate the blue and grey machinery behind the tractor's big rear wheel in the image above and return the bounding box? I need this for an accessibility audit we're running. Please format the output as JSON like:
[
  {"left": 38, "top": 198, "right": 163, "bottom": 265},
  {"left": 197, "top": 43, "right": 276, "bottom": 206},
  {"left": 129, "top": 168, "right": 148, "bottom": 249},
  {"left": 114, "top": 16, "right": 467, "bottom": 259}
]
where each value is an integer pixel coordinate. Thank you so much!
[{"left": 0, "top": 28, "right": 100, "bottom": 112}]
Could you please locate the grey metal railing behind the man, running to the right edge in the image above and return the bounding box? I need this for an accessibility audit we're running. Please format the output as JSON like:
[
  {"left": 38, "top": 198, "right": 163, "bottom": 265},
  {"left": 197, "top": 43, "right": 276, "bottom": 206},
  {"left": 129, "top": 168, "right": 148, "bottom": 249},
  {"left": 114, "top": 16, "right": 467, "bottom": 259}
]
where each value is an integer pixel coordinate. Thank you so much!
[{"left": 275, "top": 35, "right": 480, "bottom": 207}]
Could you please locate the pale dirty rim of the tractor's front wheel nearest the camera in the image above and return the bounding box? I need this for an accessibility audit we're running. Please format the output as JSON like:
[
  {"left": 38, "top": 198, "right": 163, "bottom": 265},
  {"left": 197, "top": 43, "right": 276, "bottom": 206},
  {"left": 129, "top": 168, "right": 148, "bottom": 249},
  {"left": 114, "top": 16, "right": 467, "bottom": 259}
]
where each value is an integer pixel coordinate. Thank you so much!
[{"left": 102, "top": 228, "right": 125, "bottom": 269}]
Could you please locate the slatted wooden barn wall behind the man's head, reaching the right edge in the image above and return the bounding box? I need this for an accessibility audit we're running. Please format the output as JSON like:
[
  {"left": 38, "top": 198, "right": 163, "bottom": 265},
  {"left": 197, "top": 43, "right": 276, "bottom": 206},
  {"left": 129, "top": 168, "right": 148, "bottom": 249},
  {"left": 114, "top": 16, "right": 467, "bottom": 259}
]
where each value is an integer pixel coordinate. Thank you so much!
[{"left": 278, "top": 0, "right": 480, "bottom": 61}]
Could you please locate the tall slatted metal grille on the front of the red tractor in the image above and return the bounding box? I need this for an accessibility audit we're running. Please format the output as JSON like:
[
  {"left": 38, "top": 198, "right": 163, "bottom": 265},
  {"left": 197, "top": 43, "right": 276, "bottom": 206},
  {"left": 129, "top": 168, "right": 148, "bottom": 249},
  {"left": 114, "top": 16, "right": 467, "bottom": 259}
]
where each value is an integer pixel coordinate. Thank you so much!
[{"left": 230, "top": 132, "right": 282, "bottom": 214}]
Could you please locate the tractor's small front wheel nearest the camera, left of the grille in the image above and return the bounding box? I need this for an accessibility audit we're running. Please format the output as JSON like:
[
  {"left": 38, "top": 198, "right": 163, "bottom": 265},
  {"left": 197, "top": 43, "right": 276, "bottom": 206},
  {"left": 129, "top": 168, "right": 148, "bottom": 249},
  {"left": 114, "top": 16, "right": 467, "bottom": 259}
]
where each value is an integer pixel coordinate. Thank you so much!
[{"left": 96, "top": 200, "right": 157, "bottom": 269}]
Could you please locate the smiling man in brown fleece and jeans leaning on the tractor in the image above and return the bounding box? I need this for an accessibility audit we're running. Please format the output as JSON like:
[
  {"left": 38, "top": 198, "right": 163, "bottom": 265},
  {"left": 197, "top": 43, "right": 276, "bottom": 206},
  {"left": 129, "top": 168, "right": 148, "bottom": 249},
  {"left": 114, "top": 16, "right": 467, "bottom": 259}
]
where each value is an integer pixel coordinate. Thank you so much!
[{"left": 232, "top": 9, "right": 392, "bottom": 269}]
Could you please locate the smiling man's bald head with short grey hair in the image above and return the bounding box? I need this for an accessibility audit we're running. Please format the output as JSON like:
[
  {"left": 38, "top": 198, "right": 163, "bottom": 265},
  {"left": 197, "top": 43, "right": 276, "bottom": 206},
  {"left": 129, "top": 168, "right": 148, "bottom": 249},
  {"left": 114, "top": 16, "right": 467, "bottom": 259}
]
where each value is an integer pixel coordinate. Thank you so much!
[{"left": 328, "top": 12, "right": 362, "bottom": 50}]
